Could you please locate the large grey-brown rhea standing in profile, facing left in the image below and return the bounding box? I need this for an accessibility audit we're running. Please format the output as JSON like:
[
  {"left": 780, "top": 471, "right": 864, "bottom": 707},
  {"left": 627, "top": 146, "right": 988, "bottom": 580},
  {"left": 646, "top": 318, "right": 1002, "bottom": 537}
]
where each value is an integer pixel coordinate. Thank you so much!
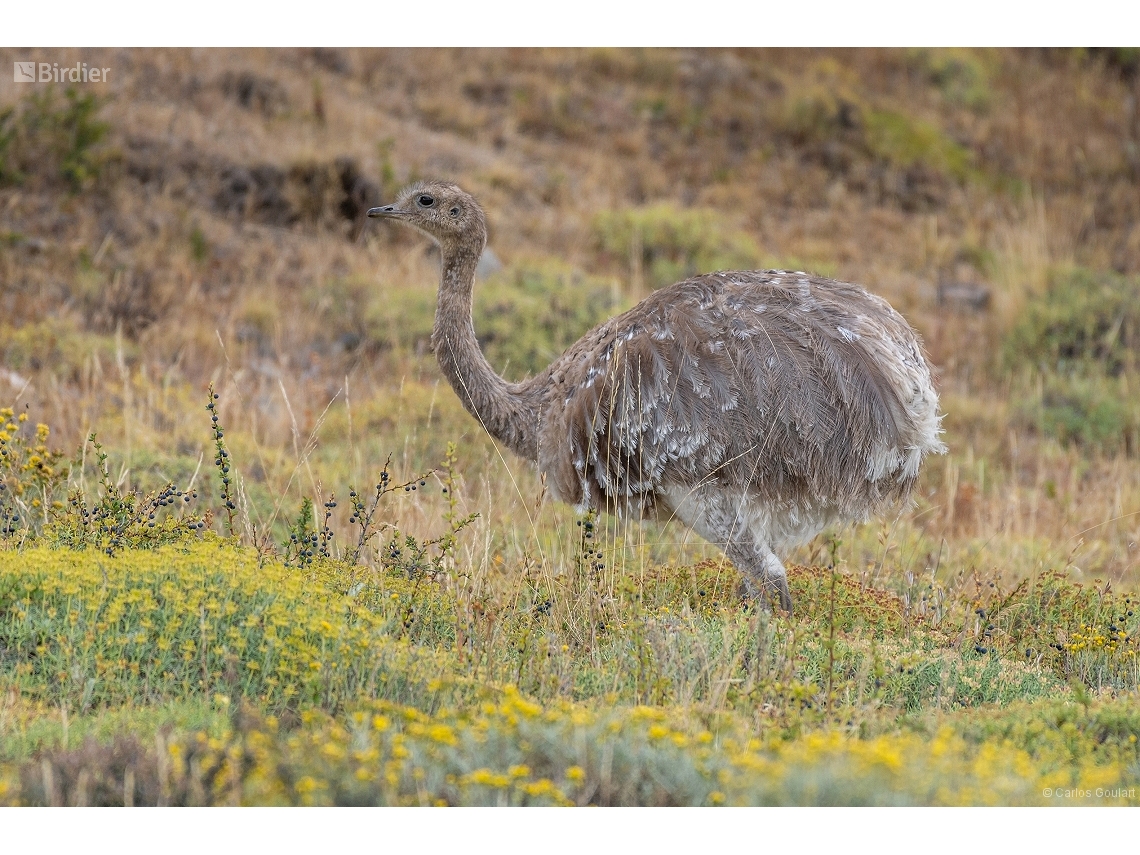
[{"left": 368, "top": 182, "right": 945, "bottom": 611}]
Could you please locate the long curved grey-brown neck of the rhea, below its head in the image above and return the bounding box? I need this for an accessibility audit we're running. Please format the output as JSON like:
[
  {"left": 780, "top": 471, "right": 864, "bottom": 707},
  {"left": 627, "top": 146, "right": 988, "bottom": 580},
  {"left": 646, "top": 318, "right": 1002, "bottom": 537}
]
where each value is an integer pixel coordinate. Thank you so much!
[{"left": 431, "top": 241, "right": 538, "bottom": 461}]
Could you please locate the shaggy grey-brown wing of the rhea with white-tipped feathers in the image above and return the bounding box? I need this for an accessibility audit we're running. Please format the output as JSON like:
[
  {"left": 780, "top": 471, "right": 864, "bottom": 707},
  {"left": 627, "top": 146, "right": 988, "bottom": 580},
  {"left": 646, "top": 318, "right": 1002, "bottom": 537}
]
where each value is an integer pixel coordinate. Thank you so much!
[{"left": 539, "top": 272, "right": 933, "bottom": 515}]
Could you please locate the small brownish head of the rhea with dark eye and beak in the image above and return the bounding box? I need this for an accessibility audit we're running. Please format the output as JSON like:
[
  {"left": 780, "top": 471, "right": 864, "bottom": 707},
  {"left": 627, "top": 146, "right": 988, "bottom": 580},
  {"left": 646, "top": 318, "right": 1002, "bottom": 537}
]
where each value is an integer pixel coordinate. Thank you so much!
[{"left": 368, "top": 181, "right": 487, "bottom": 250}]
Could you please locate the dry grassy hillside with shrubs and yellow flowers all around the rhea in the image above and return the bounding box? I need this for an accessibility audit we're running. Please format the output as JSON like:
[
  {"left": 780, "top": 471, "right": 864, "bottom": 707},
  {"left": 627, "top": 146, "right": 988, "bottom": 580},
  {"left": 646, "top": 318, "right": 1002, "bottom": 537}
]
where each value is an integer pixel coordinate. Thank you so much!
[{"left": 0, "top": 50, "right": 1140, "bottom": 804}]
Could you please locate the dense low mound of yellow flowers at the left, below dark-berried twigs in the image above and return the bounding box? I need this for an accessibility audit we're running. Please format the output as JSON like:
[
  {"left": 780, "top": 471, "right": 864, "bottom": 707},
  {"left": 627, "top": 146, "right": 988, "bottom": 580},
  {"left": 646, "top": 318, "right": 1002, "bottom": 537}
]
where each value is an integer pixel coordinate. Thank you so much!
[{"left": 0, "top": 538, "right": 462, "bottom": 709}]
